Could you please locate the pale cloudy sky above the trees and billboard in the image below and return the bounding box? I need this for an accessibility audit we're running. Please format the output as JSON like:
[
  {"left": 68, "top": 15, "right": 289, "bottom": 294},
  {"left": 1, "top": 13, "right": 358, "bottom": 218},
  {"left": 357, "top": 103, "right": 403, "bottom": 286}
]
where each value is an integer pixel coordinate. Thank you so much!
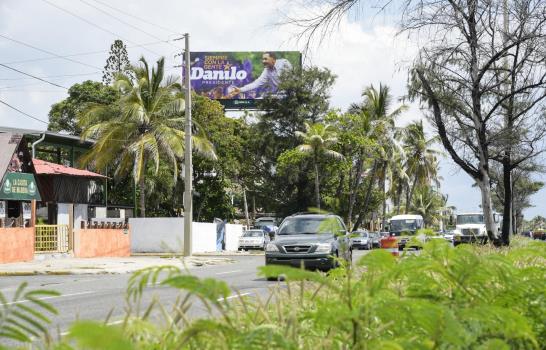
[{"left": 0, "top": 0, "right": 546, "bottom": 218}]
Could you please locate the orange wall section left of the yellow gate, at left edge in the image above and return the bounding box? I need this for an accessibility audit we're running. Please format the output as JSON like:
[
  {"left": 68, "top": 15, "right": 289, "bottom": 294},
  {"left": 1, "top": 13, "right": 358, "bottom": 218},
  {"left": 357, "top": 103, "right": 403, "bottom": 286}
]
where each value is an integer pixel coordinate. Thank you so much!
[{"left": 0, "top": 227, "right": 34, "bottom": 264}]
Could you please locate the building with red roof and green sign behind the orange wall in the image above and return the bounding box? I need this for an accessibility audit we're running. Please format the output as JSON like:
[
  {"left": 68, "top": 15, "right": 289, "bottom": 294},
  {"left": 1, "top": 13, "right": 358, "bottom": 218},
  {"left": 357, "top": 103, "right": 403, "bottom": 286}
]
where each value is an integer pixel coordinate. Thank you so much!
[{"left": 0, "top": 127, "right": 132, "bottom": 226}]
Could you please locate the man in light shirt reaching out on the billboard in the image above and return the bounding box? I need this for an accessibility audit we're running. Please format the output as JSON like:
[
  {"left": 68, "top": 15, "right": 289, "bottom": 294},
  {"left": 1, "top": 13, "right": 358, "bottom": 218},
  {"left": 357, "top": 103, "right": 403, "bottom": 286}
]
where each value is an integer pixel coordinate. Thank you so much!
[{"left": 228, "top": 52, "right": 292, "bottom": 98}]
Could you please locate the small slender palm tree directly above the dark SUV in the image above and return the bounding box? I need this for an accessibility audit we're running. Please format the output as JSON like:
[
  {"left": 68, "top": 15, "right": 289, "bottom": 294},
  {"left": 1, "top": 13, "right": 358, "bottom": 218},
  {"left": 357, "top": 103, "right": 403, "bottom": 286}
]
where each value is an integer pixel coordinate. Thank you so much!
[{"left": 296, "top": 122, "right": 343, "bottom": 209}]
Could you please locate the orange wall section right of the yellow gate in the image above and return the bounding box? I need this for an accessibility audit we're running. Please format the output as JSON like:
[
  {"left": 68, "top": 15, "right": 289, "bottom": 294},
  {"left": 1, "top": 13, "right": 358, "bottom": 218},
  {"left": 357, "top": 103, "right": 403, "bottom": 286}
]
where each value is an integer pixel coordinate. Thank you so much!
[{"left": 74, "top": 229, "right": 131, "bottom": 258}]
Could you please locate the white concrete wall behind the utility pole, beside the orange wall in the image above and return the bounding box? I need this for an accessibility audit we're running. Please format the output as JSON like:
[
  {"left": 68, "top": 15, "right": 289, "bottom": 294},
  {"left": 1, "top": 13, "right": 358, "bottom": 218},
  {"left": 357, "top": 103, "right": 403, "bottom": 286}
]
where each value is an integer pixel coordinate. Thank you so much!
[{"left": 129, "top": 218, "right": 240, "bottom": 253}]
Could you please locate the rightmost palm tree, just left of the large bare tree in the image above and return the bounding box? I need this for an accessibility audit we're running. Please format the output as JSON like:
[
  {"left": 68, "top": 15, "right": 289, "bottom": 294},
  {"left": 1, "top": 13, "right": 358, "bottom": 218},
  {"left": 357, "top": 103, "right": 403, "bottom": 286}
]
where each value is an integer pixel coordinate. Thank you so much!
[{"left": 403, "top": 121, "right": 440, "bottom": 213}]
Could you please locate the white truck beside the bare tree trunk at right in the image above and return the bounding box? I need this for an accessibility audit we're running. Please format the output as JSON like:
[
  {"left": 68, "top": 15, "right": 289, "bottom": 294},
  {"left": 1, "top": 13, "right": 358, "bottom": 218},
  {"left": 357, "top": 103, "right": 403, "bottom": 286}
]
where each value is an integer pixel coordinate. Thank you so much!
[{"left": 453, "top": 212, "right": 502, "bottom": 245}]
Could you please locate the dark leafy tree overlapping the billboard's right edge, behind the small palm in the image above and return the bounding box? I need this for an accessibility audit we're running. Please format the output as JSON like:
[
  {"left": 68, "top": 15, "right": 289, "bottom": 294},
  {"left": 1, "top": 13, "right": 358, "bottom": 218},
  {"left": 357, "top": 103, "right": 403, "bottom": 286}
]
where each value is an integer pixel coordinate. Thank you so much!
[{"left": 250, "top": 67, "right": 335, "bottom": 216}]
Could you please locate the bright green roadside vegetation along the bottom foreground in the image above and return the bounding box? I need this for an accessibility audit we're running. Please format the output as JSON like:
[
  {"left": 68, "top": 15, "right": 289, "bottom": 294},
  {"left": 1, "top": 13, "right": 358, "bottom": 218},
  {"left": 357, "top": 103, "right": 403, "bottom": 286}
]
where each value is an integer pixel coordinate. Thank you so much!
[{"left": 0, "top": 238, "right": 546, "bottom": 350}]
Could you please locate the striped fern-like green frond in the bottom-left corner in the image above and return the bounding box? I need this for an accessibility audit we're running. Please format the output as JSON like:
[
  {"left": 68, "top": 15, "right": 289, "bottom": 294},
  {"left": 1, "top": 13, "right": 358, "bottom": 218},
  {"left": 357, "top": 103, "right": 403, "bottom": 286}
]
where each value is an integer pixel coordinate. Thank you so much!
[{"left": 0, "top": 282, "right": 59, "bottom": 343}]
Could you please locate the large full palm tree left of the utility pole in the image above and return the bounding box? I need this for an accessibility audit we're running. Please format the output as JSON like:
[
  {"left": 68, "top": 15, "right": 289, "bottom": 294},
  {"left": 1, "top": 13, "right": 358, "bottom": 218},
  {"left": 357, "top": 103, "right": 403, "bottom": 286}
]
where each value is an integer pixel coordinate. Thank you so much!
[{"left": 79, "top": 57, "right": 216, "bottom": 217}]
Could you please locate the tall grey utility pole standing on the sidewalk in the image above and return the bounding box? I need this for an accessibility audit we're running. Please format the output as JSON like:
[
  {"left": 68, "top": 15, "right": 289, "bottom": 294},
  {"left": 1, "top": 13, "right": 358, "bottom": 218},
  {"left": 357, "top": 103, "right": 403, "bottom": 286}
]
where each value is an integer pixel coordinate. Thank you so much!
[{"left": 183, "top": 33, "right": 193, "bottom": 256}]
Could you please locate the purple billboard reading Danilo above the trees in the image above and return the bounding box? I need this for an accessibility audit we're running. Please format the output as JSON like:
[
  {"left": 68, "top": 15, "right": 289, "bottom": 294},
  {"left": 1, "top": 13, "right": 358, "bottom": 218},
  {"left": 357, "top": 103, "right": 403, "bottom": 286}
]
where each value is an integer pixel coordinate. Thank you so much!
[{"left": 190, "top": 51, "right": 301, "bottom": 108}]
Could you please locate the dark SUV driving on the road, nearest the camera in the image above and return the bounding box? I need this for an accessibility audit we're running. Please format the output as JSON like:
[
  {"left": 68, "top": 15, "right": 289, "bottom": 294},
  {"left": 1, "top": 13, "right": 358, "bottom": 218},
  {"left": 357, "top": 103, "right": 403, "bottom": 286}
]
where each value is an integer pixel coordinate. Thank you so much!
[{"left": 265, "top": 214, "right": 352, "bottom": 271}]
